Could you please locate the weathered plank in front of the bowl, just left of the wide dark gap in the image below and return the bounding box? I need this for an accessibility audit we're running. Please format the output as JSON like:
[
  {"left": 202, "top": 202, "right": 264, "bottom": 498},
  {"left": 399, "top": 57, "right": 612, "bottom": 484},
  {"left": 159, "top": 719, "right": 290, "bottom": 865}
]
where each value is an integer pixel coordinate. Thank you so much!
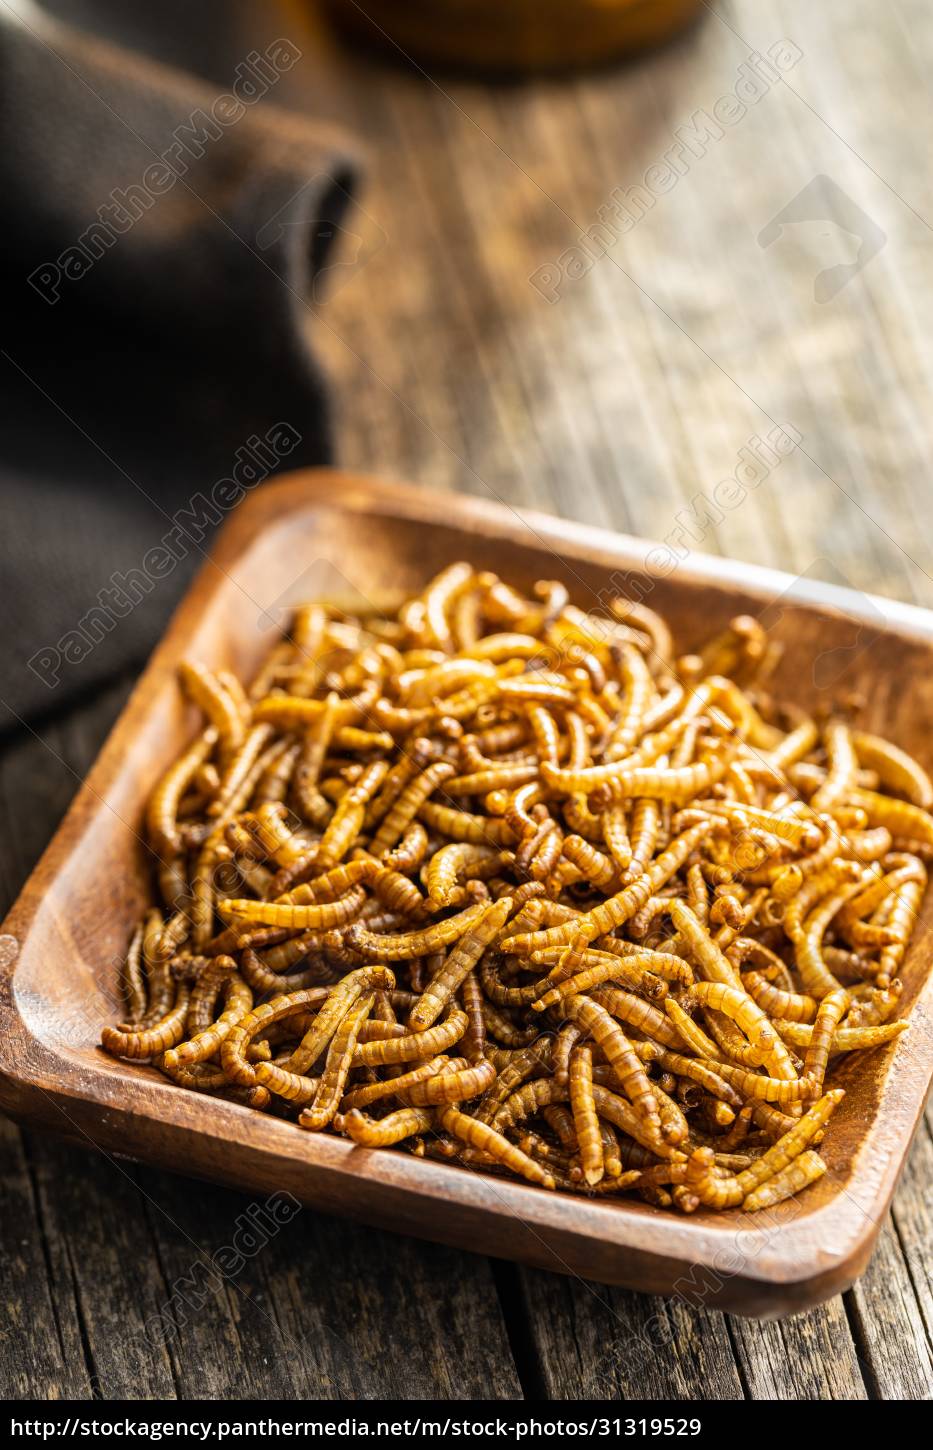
[{"left": 139, "top": 1169, "right": 519, "bottom": 1399}]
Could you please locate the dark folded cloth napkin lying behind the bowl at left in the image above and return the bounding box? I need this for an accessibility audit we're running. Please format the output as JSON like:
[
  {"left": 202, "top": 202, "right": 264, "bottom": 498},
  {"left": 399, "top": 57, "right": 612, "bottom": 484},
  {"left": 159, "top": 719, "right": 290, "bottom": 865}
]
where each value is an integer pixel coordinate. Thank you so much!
[{"left": 0, "top": 4, "right": 357, "bottom": 728}]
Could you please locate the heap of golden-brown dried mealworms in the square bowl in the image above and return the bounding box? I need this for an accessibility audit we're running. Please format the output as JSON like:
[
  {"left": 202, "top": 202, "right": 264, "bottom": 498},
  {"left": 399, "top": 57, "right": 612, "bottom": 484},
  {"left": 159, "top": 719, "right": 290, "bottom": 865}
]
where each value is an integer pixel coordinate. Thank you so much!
[{"left": 103, "top": 563, "right": 933, "bottom": 1212}]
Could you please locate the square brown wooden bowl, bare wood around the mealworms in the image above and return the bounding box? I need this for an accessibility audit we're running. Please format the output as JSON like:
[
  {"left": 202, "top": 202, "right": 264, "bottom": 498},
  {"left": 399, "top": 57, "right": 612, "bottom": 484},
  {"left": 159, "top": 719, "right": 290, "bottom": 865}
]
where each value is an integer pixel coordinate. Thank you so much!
[{"left": 0, "top": 471, "right": 933, "bottom": 1315}]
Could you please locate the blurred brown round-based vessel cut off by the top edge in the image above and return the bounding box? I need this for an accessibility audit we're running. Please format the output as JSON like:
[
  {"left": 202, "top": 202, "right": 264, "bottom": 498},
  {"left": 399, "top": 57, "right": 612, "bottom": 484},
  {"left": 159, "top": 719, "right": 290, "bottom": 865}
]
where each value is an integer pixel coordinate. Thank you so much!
[{"left": 328, "top": 0, "right": 704, "bottom": 74}]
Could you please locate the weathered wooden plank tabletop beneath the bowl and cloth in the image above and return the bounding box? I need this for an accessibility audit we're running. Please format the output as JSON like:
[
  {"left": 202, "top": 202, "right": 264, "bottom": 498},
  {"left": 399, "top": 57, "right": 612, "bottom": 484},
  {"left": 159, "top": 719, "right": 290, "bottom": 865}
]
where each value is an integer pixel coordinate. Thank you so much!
[{"left": 0, "top": 0, "right": 933, "bottom": 1399}]
